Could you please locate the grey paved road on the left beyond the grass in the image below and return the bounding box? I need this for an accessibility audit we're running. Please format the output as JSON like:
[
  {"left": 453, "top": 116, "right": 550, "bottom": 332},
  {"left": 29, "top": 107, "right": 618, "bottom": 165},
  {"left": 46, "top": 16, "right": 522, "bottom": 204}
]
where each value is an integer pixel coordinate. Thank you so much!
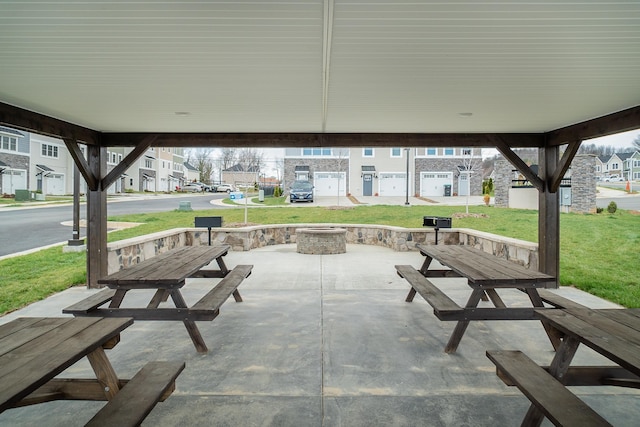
[{"left": 0, "top": 193, "right": 226, "bottom": 257}]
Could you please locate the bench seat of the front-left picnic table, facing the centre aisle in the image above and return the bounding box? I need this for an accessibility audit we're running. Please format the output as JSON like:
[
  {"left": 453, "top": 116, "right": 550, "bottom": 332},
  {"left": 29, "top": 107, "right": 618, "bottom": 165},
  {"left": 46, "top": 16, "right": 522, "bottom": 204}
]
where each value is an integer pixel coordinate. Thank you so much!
[{"left": 86, "top": 362, "right": 185, "bottom": 426}]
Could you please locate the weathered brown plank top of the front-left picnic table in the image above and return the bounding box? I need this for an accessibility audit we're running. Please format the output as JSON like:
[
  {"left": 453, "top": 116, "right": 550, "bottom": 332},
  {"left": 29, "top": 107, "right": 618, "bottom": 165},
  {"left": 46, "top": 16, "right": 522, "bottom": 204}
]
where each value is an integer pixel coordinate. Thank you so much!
[{"left": 0, "top": 318, "right": 133, "bottom": 412}]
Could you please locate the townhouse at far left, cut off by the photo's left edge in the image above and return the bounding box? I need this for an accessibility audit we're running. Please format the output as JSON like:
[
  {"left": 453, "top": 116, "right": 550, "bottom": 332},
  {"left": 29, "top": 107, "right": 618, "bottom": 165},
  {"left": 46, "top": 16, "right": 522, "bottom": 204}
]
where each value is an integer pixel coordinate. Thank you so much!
[{"left": 0, "top": 126, "right": 30, "bottom": 194}]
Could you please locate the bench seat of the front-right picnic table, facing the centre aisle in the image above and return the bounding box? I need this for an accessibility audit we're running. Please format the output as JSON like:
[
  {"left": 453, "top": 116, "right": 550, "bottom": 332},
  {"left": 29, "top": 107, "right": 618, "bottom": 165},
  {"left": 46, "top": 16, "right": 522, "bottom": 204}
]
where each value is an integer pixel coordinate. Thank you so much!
[{"left": 487, "top": 350, "right": 611, "bottom": 427}]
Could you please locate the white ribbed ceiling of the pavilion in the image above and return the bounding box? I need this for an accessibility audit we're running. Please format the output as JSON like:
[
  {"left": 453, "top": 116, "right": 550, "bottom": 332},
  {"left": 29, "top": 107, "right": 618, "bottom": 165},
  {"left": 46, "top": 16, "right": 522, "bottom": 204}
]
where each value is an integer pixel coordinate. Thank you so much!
[{"left": 0, "top": 0, "right": 640, "bottom": 132}]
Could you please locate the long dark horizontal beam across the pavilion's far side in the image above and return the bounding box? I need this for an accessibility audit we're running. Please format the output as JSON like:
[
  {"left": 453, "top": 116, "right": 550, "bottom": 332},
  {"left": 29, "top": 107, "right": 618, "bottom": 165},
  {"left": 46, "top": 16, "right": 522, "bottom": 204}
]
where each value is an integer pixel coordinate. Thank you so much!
[{"left": 101, "top": 132, "right": 545, "bottom": 148}]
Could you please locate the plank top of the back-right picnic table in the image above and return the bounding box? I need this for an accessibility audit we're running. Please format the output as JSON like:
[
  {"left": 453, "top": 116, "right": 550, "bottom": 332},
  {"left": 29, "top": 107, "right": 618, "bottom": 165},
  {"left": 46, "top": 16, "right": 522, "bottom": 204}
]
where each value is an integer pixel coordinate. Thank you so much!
[{"left": 417, "top": 244, "right": 555, "bottom": 285}]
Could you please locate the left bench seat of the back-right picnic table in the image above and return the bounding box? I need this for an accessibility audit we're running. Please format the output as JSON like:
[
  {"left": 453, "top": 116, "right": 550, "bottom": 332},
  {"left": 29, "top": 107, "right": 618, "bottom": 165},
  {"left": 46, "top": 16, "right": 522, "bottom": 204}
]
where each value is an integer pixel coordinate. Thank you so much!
[{"left": 395, "top": 265, "right": 464, "bottom": 320}]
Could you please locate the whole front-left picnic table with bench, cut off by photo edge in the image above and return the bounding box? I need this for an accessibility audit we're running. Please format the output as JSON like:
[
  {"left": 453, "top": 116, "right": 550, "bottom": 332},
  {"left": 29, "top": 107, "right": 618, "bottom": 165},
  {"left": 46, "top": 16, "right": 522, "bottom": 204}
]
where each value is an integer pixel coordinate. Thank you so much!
[{"left": 0, "top": 317, "right": 185, "bottom": 425}]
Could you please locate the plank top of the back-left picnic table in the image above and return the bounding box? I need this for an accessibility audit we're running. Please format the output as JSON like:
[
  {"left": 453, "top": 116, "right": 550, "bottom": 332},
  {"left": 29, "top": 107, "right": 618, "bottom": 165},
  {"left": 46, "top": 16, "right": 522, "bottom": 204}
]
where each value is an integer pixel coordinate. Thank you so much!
[{"left": 98, "top": 245, "right": 230, "bottom": 287}]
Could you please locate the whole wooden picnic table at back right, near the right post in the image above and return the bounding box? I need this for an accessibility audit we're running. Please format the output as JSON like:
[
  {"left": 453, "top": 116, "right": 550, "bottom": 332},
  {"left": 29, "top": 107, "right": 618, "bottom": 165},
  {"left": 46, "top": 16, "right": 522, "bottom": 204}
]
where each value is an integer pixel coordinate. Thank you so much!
[{"left": 395, "top": 244, "right": 559, "bottom": 353}]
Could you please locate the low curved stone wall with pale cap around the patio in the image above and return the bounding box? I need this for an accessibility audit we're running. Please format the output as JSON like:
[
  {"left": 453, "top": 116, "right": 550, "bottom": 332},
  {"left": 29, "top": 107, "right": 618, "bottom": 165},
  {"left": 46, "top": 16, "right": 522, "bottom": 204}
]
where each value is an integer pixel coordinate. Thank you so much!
[{"left": 107, "top": 224, "right": 538, "bottom": 273}]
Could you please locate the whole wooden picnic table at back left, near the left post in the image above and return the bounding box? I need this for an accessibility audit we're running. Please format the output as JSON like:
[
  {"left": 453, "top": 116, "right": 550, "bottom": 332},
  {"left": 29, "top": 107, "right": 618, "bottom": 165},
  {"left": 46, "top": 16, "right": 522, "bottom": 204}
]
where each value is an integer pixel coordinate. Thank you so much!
[{"left": 62, "top": 245, "right": 253, "bottom": 353}]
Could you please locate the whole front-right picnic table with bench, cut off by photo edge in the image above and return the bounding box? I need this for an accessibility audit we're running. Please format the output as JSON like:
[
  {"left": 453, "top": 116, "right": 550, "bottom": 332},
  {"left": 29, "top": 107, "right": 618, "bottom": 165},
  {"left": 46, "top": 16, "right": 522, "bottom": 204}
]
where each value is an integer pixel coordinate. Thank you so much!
[{"left": 487, "top": 307, "right": 640, "bottom": 427}]
